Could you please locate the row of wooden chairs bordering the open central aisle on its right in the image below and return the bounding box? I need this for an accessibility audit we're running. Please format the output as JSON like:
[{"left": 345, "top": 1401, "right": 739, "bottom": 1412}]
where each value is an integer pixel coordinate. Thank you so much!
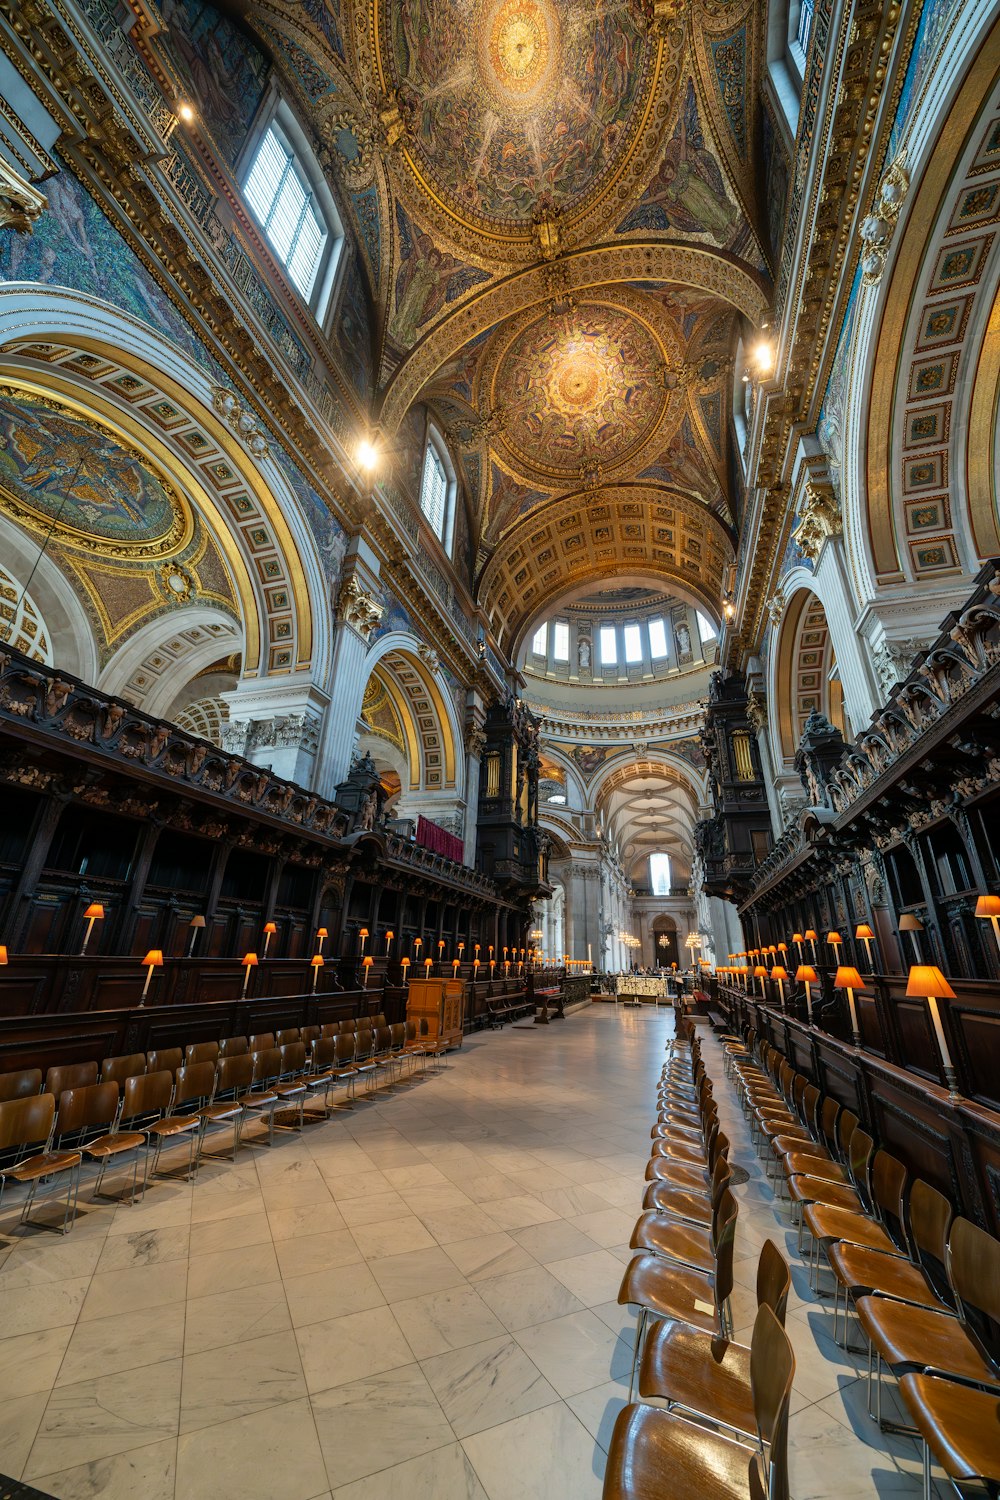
[{"left": 604, "top": 1017, "right": 795, "bottom": 1500}]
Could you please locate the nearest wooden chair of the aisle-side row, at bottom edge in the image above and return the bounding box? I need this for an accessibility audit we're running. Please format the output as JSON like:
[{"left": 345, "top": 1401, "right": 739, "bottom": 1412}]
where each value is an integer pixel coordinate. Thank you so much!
[{"left": 604, "top": 1307, "right": 795, "bottom": 1500}]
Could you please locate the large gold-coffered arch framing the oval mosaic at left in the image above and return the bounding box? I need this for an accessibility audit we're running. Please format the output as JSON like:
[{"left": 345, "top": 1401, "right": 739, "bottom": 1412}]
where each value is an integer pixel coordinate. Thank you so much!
[{"left": 0, "top": 284, "right": 331, "bottom": 683}]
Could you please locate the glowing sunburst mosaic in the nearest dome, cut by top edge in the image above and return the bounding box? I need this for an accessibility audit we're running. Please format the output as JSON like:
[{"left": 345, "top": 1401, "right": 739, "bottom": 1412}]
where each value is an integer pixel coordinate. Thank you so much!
[{"left": 379, "top": 0, "right": 655, "bottom": 228}]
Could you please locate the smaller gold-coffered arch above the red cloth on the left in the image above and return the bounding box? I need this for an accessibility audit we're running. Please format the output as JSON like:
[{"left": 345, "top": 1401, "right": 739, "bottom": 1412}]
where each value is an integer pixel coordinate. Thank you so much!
[{"left": 364, "top": 630, "right": 465, "bottom": 803}]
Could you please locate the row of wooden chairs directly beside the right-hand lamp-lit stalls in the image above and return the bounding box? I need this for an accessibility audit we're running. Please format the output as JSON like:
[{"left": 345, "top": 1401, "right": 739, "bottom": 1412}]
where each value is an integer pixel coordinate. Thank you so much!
[{"left": 726, "top": 1034, "right": 1000, "bottom": 1497}]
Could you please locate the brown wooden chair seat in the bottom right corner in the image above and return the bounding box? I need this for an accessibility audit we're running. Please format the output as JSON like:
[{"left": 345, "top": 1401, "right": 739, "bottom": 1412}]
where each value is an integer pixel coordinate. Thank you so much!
[{"left": 900, "top": 1374, "right": 1000, "bottom": 1496}]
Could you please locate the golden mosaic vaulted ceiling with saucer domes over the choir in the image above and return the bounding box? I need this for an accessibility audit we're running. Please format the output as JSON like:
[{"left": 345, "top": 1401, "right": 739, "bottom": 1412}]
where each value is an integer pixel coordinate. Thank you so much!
[{"left": 238, "top": 0, "right": 771, "bottom": 639}]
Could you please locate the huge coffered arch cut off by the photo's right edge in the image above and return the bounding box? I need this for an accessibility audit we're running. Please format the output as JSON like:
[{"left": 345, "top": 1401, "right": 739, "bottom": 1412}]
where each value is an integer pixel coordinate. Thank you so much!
[{"left": 825, "top": 0, "right": 1000, "bottom": 603}]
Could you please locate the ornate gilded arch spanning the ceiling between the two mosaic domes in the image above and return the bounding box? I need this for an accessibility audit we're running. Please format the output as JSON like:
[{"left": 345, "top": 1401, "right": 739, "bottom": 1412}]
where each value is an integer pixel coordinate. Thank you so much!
[{"left": 379, "top": 240, "right": 769, "bottom": 438}]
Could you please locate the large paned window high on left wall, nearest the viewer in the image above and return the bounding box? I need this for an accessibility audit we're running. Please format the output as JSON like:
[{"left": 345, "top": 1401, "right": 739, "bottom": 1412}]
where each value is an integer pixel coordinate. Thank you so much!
[{"left": 243, "top": 101, "right": 343, "bottom": 321}]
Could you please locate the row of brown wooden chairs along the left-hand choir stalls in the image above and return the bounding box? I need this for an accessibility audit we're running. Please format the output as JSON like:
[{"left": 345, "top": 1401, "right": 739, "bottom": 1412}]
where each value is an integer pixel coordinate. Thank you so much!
[{"left": 0, "top": 1017, "right": 442, "bottom": 1233}]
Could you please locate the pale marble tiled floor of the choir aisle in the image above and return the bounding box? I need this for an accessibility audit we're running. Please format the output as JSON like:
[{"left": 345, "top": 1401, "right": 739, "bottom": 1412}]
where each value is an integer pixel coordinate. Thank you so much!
[{"left": 0, "top": 1005, "right": 935, "bottom": 1500}]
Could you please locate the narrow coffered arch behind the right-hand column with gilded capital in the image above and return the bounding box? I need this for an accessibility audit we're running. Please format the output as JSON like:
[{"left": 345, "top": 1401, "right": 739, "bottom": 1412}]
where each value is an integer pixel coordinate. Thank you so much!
[{"left": 772, "top": 588, "right": 850, "bottom": 764}]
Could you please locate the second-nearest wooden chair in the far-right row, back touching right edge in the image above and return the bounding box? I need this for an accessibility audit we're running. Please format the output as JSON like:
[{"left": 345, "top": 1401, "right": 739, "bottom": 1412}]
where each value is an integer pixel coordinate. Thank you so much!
[{"left": 856, "top": 1218, "right": 1000, "bottom": 1431}]
